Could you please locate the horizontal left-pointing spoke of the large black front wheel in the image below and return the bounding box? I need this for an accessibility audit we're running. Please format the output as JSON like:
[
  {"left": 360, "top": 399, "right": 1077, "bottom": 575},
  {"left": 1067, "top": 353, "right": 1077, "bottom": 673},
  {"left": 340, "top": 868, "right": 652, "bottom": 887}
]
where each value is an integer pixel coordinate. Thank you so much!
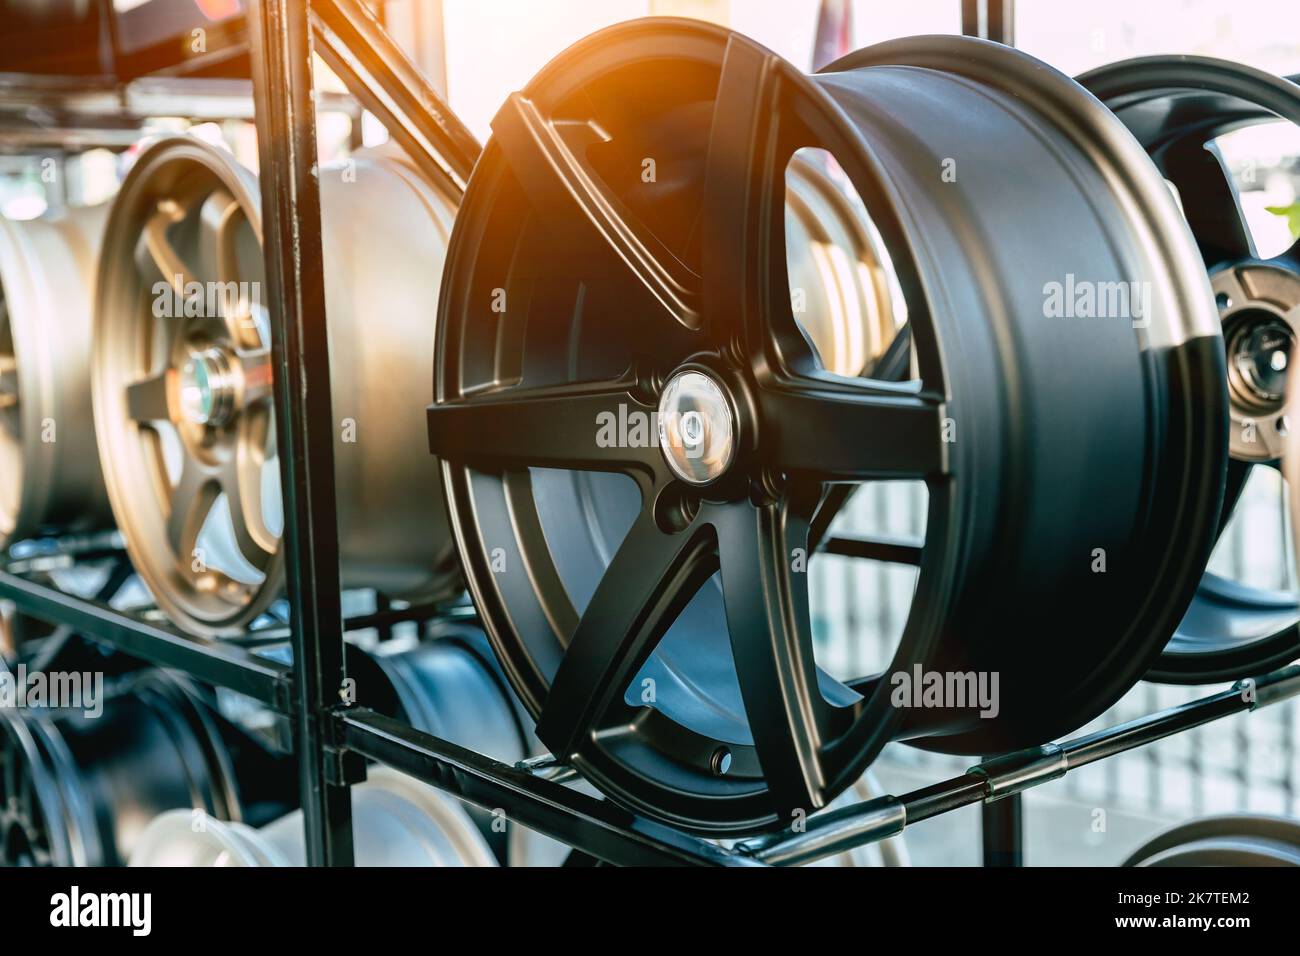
[{"left": 429, "top": 382, "right": 664, "bottom": 473}]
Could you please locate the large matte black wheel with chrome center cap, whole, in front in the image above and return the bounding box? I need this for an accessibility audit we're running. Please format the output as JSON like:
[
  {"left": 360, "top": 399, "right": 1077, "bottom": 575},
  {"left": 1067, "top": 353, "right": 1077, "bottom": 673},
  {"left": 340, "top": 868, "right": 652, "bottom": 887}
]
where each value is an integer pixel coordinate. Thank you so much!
[{"left": 429, "top": 20, "right": 1227, "bottom": 834}]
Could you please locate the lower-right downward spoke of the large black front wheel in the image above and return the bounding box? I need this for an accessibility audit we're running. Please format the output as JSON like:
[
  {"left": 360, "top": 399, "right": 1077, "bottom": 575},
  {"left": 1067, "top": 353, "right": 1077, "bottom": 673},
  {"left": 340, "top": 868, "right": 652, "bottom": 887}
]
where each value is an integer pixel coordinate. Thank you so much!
[{"left": 711, "top": 498, "right": 828, "bottom": 819}]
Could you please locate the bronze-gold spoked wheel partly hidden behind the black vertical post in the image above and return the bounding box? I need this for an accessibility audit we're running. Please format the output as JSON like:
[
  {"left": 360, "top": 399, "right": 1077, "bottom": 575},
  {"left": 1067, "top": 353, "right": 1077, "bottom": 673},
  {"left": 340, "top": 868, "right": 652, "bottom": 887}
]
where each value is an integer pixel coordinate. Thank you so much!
[{"left": 94, "top": 138, "right": 460, "bottom": 636}]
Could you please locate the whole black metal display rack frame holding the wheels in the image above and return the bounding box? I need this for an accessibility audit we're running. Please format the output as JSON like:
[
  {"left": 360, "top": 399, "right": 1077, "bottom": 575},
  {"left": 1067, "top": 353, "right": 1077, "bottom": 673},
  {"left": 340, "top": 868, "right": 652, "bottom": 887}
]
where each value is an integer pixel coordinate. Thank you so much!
[{"left": 0, "top": 0, "right": 1300, "bottom": 866}]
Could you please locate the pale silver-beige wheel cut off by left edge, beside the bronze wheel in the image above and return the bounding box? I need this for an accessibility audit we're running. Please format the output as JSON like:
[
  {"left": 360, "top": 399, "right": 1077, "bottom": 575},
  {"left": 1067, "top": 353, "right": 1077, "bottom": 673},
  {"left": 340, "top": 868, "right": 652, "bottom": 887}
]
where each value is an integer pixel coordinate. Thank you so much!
[{"left": 0, "top": 207, "right": 111, "bottom": 546}]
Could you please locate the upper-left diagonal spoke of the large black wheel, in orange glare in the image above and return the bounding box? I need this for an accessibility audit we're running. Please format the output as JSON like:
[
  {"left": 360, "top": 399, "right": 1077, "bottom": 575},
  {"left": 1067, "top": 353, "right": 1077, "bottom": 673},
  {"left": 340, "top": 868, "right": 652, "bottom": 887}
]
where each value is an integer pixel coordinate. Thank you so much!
[{"left": 493, "top": 94, "right": 699, "bottom": 329}]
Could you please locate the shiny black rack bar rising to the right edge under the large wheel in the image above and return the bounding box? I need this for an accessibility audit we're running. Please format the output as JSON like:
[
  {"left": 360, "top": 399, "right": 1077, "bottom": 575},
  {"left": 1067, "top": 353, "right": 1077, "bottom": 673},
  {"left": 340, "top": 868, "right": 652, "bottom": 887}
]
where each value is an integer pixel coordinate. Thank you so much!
[{"left": 738, "top": 665, "right": 1300, "bottom": 862}]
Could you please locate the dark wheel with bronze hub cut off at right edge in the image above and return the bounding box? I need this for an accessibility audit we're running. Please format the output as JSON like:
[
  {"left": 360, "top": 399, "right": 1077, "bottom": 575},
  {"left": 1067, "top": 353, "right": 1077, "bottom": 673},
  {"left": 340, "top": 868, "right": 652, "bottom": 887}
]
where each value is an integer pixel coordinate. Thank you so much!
[{"left": 1079, "top": 56, "right": 1300, "bottom": 684}]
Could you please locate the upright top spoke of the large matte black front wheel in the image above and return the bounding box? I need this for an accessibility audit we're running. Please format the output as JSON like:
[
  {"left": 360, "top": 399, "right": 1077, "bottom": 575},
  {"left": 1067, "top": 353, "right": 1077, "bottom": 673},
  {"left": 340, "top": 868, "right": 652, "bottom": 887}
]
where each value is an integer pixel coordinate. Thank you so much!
[{"left": 701, "top": 38, "right": 814, "bottom": 368}]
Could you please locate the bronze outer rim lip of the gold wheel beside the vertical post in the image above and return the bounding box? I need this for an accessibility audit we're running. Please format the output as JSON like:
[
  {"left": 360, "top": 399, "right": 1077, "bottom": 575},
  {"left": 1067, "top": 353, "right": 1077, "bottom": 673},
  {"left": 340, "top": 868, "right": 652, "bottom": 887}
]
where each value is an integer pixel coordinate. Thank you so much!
[{"left": 91, "top": 135, "right": 283, "bottom": 636}]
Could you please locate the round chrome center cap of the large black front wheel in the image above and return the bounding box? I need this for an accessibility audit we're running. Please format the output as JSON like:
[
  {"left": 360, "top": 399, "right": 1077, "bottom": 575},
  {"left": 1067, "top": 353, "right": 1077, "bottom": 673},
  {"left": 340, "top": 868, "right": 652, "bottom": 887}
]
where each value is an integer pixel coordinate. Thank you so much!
[{"left": 659, "top": 371, "right": 736, "bottom": 485}]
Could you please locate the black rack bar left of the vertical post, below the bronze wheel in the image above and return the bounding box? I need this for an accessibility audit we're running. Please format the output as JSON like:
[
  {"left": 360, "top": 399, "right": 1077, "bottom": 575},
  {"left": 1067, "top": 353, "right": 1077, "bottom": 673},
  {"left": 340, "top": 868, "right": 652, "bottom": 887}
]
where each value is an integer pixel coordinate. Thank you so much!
[{"left": 0, "top": 571, "right": 294, "bottom": 714}]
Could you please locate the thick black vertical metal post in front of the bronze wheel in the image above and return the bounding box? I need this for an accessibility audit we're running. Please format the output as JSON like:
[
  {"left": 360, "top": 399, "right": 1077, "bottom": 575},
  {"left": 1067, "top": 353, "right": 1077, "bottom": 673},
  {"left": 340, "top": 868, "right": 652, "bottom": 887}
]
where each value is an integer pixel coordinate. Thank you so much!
[{"left": 248, "top": 0, "right": 352, "bottom": 866}]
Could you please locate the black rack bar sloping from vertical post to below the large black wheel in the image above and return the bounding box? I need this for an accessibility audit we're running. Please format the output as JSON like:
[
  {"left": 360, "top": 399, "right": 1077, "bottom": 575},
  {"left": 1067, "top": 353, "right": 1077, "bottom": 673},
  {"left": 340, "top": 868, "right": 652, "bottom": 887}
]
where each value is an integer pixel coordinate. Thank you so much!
[{"left": 335, "top": 709, "right": 761, "bottom": 866}]
